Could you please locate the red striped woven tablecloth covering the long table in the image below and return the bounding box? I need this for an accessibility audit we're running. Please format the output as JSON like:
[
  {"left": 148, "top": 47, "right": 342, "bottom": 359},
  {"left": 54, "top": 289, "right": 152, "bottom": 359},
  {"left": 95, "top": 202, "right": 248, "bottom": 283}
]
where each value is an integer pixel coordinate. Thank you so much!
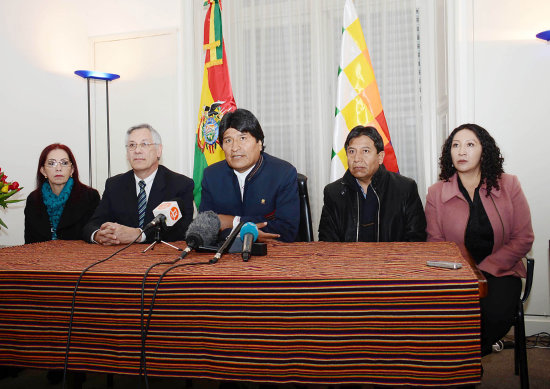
[{"left": 0, "top": 241, "right": 481, "bottom": 387}]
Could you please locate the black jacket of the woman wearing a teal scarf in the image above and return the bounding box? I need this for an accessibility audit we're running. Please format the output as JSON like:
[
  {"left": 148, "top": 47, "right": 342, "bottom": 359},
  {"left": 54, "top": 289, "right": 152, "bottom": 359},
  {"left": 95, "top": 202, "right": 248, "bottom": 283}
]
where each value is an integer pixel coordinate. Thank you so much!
[{"left": 25, "top": 182, "right": 99, "bottom": 243}]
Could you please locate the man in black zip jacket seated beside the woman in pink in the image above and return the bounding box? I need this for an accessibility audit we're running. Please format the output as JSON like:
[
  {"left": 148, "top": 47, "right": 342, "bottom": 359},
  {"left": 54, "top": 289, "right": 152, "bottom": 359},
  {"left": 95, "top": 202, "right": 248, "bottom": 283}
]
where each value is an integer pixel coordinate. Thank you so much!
[{"left": 319, "top": 126, "right": 426, "bottom": 242}]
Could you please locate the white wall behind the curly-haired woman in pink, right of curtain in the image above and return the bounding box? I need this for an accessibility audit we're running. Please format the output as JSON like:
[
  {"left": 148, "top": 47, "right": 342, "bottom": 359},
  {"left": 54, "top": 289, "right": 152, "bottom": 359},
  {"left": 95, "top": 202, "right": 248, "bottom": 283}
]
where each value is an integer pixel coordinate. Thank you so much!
[{"left": 450, "top": 0, "right": 550, "bottom": 333}]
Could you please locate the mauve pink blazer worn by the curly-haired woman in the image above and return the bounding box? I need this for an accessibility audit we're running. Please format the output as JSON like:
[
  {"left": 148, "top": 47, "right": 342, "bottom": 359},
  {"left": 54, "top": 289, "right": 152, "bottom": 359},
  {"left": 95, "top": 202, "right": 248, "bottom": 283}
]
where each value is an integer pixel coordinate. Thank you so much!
[{"left": 425, "top": 173, "right": 534, "bottom": 277}]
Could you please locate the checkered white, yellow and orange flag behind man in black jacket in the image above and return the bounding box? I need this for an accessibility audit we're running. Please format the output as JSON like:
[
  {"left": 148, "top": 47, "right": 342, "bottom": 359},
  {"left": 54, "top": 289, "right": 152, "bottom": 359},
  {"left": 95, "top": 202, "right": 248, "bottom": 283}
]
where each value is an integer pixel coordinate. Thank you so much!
[{"left": 330, "top": 0, "right": 399, "bottom": 182}]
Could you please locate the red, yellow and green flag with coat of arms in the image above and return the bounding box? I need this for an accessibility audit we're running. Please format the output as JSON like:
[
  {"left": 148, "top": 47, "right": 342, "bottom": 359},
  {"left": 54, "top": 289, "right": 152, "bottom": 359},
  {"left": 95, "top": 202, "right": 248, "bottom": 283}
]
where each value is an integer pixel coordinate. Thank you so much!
[{"left": 193, "top": 0, "right": 236, "bottom": 209}]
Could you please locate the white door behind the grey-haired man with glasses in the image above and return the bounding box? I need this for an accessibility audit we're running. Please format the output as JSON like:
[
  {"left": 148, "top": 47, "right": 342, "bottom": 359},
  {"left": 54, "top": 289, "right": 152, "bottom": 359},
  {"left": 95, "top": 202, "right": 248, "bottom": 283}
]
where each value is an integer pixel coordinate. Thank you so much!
[{"left": 91, "top": 30, "right": 180, "bottom": 193}]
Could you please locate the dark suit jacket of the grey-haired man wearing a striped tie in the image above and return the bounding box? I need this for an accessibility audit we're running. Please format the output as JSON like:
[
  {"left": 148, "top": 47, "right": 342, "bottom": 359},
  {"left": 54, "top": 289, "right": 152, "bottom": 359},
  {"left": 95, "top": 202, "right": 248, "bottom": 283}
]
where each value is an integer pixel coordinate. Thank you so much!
[{"left": 82, "top": 165, "right": 194, "bottom": 242}]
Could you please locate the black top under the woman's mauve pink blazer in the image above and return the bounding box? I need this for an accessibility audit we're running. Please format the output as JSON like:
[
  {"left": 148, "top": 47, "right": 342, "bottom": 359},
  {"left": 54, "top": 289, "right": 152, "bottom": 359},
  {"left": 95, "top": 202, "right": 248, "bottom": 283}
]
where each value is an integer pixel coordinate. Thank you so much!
[{"left": 457, "top": 175, "right": 495, "bottom": 263}]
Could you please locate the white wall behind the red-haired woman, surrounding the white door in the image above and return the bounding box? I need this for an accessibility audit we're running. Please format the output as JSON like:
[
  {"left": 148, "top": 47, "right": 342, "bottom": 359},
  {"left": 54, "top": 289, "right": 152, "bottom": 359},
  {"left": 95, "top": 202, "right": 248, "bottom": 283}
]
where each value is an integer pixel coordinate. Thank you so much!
[{"left": 0, "top": 0, "right": 190, "bottom": 245}]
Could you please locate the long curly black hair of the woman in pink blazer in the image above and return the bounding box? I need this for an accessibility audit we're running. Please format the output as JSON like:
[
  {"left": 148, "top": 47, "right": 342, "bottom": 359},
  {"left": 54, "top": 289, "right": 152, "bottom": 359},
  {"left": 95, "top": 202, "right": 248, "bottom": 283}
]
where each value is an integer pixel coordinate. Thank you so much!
[{"left": 439, "top": 124, "right": 504, "bottom": 196}]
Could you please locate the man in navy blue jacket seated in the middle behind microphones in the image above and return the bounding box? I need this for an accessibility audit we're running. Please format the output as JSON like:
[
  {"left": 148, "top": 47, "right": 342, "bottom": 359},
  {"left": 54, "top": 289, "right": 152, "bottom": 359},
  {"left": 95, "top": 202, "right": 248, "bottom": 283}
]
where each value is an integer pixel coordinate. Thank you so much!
[{"left": 199, "top": 109, "right": 300, "bottom": 242}]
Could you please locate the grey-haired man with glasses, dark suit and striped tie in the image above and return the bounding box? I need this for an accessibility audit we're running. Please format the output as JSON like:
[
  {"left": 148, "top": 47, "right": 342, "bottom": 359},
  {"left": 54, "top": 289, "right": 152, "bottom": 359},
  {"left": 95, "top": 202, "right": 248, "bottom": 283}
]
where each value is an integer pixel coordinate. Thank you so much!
[{"left": 83, "top": 124, "right": 194, "bottom": 245}]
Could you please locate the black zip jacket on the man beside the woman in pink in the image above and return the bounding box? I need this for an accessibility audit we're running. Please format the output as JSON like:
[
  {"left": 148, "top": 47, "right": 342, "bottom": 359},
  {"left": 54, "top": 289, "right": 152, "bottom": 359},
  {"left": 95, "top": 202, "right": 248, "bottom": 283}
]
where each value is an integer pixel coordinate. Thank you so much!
[{"left": 319, "top": 165, "right": 426, "bottom": 242}]
